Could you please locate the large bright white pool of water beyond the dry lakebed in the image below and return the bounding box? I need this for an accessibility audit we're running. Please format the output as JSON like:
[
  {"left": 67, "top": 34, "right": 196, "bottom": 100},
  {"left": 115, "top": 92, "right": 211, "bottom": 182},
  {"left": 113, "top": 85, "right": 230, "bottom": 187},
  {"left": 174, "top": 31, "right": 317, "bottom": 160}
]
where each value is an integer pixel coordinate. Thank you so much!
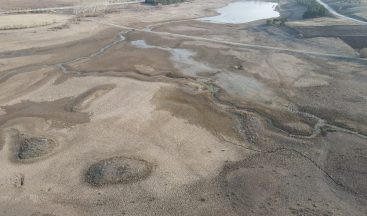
[{"left": 199, "top": 1, "right": 279, "bottom": 24}]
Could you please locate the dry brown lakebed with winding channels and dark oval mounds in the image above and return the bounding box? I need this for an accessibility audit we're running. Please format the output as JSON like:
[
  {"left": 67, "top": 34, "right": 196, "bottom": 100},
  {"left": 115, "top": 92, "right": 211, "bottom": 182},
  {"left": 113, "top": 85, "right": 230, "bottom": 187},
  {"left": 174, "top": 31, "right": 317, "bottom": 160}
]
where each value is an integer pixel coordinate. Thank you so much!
[{"left": 0, "top": 0, "right": 367, "bottom": 216}]
